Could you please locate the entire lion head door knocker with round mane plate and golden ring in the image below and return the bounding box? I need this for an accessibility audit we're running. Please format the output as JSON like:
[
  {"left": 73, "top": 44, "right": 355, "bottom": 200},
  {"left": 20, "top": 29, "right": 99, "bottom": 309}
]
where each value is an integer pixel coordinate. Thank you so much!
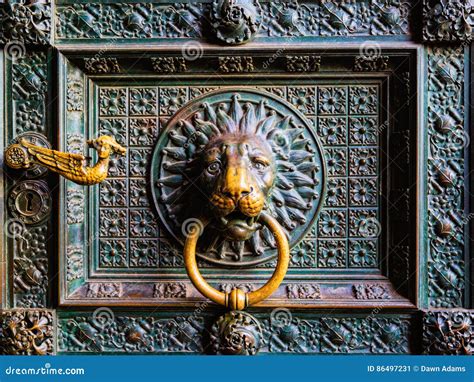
[{"left": 152, "top": 88, "right": 325, "bottom": 310}]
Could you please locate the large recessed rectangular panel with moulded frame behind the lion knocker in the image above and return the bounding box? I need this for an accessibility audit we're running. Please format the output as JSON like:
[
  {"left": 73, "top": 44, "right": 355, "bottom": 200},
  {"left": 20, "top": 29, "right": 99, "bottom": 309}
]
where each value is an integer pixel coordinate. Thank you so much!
[{"left": 56, "top": 51, "right": 416, "bottom": 307}]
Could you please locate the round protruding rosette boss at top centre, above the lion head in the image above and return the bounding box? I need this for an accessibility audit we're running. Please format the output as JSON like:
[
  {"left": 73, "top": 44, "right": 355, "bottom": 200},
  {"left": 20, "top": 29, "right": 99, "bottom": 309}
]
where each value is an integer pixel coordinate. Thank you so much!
[{"left": 211, "top": 0, "right": 262, "bottom": 45}]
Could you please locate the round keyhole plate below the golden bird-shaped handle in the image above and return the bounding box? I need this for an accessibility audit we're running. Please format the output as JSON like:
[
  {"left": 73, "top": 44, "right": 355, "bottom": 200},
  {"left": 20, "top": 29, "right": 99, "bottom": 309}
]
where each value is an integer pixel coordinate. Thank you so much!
[{"left": 8, "top": 180, "right": 51, "bottom": 224}]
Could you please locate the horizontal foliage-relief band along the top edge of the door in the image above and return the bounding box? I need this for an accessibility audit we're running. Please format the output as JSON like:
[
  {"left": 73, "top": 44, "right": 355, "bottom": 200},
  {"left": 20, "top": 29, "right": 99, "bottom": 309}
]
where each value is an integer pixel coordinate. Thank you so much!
[{"left": 55, "top": 0, "right": 414, "bottom": 44}]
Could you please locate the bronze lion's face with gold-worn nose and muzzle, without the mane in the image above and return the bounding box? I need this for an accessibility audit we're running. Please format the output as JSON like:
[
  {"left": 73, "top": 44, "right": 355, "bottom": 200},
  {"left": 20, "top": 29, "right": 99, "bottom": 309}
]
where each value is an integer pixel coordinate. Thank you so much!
[{"left": 201, "top": 134, "right": 275, "bottom": 240}]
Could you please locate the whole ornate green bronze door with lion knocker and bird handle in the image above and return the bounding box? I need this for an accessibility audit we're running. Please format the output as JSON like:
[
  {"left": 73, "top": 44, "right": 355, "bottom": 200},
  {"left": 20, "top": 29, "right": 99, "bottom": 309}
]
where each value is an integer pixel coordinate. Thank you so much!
[{"left": 0, "top": 0, "right": 472, "bottom": 354}]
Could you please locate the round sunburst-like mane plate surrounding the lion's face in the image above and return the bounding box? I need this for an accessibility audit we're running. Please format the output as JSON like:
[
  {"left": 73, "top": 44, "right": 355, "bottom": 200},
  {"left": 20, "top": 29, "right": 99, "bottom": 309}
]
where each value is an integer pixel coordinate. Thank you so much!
[{"left": 152, "top": 89, "right": 325, "bottom": 266}]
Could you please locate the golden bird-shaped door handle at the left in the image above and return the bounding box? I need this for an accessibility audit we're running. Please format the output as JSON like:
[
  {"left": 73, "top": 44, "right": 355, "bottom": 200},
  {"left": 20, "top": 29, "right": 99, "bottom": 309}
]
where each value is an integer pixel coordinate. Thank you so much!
[{"left": 5, "top": 135, "right": 126, "bottom": 186}]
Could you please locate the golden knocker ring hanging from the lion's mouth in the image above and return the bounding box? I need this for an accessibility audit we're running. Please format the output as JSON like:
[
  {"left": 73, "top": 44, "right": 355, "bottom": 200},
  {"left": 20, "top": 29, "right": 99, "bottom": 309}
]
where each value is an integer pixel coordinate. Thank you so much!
[{"left": 184, "top": 213, "right": 290, "bottom": 310}]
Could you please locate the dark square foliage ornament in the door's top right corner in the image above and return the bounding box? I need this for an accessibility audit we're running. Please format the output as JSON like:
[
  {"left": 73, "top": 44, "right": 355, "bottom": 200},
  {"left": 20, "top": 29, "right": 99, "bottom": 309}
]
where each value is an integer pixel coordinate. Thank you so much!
[{"left": 423, "top": 0, "right": 474, "bottom": 42}]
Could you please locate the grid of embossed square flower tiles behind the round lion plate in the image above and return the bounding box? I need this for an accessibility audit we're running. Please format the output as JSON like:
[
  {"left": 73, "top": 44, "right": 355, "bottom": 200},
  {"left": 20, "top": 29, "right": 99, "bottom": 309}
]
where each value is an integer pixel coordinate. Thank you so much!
[{"left": 96, "top": 84, "right": 382, "bottom": 271}]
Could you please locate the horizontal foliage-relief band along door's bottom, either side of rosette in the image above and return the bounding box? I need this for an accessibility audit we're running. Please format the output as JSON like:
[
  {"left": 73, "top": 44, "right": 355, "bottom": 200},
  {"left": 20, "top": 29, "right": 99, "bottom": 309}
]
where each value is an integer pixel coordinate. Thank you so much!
[{"left": 58, "top": 309, "right": 416, "bottom": 354}]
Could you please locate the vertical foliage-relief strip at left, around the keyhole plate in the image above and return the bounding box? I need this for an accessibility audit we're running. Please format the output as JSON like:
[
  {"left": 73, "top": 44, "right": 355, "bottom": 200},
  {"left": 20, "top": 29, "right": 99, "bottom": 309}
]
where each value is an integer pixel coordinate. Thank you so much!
[{"left": 3, "top": 50, "right": 53, "bottom": 308}]
